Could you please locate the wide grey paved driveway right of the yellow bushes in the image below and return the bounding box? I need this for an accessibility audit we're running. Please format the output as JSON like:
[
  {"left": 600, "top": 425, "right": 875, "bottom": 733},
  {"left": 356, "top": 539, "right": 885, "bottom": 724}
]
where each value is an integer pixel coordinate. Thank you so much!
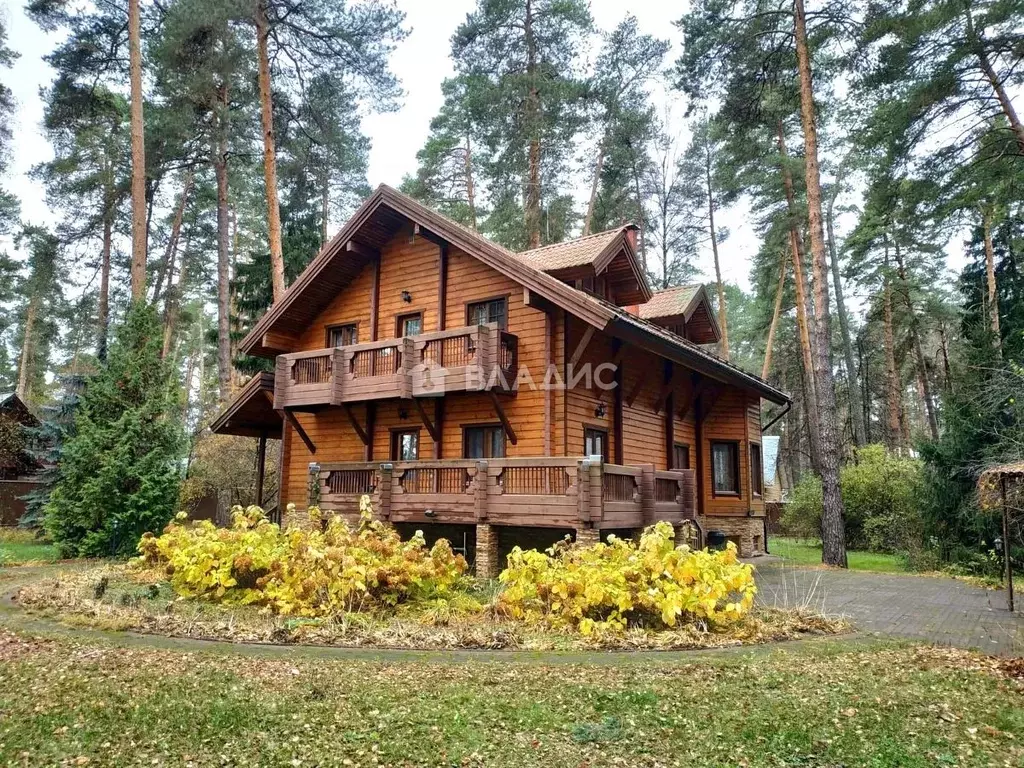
[{"left": 752, "top": 560, "right": 1024, "bottom": 655}]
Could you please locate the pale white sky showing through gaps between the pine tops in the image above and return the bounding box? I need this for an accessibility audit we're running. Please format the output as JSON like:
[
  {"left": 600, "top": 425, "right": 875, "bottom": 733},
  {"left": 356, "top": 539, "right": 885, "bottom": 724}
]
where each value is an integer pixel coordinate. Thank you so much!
[{"left": 0, "top": 0, "right": 958, "bottom": 300}]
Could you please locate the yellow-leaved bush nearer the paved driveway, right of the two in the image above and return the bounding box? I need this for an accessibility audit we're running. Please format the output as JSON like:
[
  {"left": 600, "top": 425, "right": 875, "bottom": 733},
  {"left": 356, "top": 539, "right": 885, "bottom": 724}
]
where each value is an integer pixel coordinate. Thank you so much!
[{"left": 499, "top": 522, "right": 757, "bottom": 635}]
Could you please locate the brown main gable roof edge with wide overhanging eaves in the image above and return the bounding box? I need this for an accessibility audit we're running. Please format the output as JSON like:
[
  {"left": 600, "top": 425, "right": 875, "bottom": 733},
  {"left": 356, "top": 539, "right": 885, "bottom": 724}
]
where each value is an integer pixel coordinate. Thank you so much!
[{"left": 240, "top": 184, "right": 790, "bottom": 404}]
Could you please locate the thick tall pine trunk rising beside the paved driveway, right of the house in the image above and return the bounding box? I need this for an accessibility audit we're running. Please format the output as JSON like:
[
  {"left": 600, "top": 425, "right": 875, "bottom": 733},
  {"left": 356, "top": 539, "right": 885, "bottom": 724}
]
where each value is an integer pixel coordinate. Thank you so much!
[{"left": 794, "top": 0, "right": 847, "bottom": 567}]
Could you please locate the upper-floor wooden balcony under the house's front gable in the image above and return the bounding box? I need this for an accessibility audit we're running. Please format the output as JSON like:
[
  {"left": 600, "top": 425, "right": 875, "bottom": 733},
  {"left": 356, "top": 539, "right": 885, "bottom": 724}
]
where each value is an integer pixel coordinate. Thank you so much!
[{"left": 273, "top": 326, "right": 518, "bottom": 411}]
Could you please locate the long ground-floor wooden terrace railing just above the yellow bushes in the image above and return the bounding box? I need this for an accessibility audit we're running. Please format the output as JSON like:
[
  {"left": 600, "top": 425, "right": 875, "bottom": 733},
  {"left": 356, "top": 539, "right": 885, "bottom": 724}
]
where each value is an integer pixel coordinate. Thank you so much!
[{"left": 309, "top": 457, "right": 696, "bottom": 529}]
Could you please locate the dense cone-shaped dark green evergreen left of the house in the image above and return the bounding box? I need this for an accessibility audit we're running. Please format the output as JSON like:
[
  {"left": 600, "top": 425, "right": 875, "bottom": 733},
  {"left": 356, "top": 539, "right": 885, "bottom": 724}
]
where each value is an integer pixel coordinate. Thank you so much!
[{"left": 44, "top": 302, "right": 182, "bottom": 557}]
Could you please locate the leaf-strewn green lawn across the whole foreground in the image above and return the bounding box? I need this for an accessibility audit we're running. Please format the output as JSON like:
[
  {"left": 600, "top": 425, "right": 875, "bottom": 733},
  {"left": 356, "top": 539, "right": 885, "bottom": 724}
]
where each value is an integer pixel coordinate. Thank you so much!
[{"left": 0, "top": 630, "right": 1024, "bottom": 768}]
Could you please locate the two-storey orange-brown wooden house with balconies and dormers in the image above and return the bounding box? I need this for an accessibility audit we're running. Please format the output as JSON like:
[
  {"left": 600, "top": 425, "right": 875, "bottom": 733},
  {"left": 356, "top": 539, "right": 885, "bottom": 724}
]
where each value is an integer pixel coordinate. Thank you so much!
[{"left": 213, "top": 186, "right": 788, "bottom": 573}]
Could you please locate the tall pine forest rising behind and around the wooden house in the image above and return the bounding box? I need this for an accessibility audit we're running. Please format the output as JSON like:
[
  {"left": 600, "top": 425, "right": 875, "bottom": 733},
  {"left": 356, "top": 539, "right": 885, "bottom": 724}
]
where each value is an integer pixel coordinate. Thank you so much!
[{"left": 0, "top": 0, "right": 1024, "bottom": 564}]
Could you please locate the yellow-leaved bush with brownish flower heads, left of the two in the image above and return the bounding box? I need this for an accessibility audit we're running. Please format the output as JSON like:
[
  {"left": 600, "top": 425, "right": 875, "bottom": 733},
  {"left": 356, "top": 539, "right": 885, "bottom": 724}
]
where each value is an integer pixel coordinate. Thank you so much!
[{"left": 138, "top": 497, "right": 467, "bottom": 616}]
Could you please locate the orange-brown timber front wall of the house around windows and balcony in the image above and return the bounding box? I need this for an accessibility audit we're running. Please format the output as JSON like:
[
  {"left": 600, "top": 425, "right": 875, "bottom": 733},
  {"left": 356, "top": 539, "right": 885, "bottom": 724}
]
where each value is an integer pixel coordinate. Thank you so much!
[{"left": 282, "top": 222, "right": 569, "bottom": 509}]
